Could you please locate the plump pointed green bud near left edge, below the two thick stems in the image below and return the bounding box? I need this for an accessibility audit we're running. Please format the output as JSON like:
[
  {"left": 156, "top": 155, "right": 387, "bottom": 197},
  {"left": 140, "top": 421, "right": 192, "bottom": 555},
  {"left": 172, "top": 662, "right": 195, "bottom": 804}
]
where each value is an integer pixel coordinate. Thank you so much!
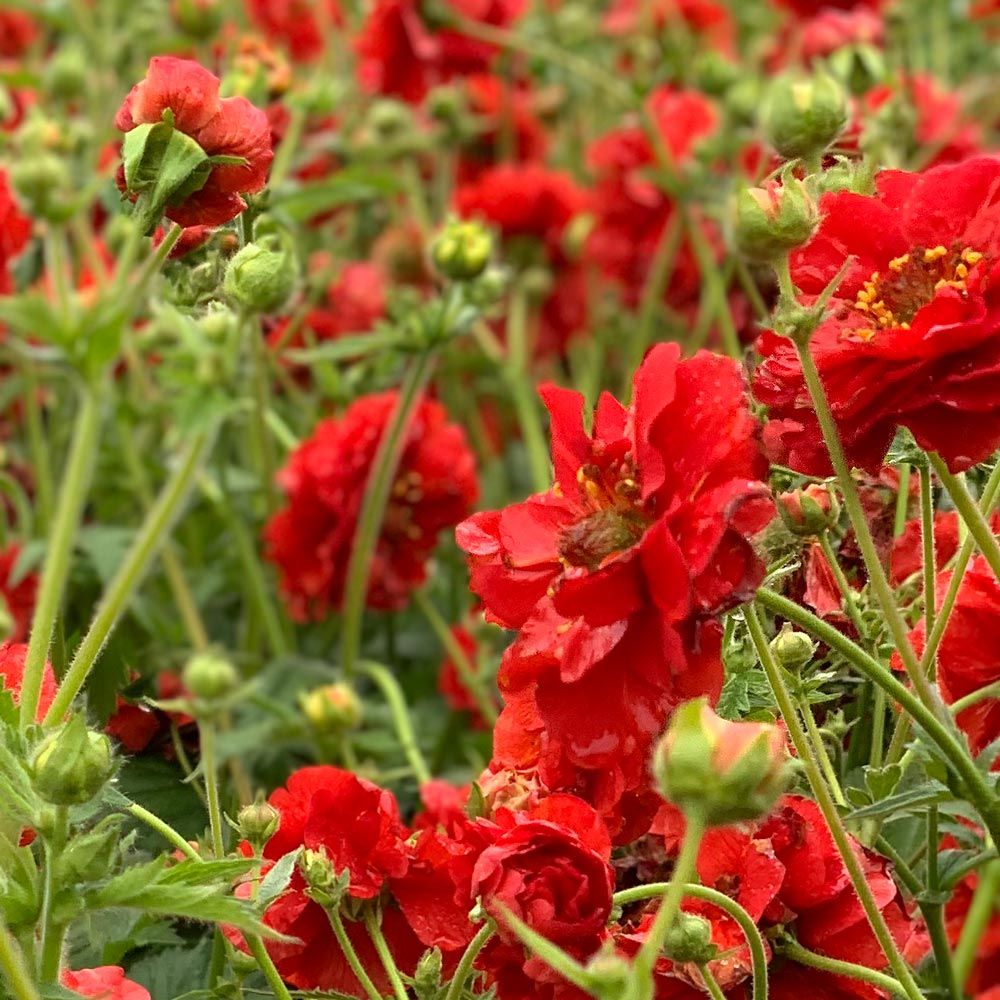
[{"left": 31, "top": 715, "right": 114, "bottom": 806}]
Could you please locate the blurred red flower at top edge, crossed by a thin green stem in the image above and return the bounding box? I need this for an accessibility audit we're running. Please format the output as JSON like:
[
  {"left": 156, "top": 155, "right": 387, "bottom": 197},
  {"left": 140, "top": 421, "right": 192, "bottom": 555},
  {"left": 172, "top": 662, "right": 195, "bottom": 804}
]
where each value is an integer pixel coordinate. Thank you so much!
[{"left": 356, "top": 0, "right": 524, "bottom": 104}]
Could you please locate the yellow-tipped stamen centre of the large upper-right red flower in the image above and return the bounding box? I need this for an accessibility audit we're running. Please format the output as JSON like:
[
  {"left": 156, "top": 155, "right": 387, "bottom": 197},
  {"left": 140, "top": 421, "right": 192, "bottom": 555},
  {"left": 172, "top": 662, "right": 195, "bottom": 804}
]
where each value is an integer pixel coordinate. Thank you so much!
[{"left": 854, "top": 246, "right": 983, "bottom": 340}]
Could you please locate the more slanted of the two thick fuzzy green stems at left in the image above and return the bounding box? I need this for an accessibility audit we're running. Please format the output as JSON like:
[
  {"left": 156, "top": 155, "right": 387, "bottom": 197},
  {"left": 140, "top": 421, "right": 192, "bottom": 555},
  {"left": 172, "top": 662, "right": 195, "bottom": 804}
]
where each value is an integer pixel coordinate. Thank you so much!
[{"left": 44, "top": 433, "right": 213, "bottom": 726}]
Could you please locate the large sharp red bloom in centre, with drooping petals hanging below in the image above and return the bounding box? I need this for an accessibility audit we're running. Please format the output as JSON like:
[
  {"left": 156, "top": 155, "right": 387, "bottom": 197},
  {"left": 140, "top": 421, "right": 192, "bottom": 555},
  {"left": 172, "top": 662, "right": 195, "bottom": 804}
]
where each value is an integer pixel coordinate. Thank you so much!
[{"left": 457, "top": 345, "right": 773, "bottom": 836}]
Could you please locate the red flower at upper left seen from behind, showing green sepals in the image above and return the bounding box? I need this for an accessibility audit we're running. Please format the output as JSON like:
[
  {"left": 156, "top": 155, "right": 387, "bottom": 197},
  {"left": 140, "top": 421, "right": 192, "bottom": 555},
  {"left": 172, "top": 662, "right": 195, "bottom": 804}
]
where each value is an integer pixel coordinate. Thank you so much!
[{"left": 115, "top": 56, "right": 274, "bottom": 229}]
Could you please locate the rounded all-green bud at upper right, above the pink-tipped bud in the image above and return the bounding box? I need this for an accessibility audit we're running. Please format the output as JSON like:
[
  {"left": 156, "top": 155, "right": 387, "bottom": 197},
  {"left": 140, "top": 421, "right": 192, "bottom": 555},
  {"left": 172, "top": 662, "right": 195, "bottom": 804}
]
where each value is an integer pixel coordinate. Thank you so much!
[{"left": 764, "top": 73, "right": 847, "bottom": 160}]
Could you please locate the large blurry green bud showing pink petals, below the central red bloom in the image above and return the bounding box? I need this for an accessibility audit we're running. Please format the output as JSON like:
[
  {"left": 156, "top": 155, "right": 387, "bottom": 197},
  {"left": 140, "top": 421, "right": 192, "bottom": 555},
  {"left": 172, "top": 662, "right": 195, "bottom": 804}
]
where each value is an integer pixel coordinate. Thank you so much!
[{"left": 653, "top": 698, "right": 788, "bottom": 826}]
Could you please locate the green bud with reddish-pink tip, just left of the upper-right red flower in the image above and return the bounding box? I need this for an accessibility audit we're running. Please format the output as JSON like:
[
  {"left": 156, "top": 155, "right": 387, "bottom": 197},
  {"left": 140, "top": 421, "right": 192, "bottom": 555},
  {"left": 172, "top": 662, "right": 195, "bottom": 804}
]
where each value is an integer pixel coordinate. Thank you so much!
[{"left": 736, "top": 176, "right": 819, "bottom": 263}]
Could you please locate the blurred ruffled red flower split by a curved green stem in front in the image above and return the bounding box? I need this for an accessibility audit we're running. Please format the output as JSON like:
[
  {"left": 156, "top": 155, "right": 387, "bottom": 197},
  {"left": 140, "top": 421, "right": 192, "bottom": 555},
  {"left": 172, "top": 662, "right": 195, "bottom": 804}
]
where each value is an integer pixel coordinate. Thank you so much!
[{"left": 266, "top": 390, "right": 477, "bottom": 620}]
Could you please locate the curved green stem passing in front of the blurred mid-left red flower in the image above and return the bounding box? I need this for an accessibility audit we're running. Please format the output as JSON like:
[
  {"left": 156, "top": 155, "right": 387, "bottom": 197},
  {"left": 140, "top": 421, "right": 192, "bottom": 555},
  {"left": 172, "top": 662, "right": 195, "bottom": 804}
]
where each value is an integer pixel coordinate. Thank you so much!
[{"left": 340, "top": 352, "right": 433, "bottom": 678}]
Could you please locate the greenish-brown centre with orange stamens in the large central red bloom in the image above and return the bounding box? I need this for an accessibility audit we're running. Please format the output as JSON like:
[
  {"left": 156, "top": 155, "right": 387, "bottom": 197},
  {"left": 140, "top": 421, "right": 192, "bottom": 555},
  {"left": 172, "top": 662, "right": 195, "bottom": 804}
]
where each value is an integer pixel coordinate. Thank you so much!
[{"left": 559, "top": 459, "right": 649, "bottom": 570}]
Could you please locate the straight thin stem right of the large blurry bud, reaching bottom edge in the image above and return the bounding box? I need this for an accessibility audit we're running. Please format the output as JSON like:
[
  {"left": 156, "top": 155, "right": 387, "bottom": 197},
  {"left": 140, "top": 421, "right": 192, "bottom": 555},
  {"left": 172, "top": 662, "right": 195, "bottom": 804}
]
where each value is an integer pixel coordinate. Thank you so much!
[{"left": 745, "top": 605, "right": 923, "bottom": 1000}]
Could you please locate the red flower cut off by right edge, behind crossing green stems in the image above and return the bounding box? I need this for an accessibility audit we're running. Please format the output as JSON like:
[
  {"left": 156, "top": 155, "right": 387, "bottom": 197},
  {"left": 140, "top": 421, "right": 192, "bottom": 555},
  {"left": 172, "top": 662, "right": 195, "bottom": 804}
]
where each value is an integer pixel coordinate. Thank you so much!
[{"left": 910, "top": 556, "right": 1000, "bottom": 753}]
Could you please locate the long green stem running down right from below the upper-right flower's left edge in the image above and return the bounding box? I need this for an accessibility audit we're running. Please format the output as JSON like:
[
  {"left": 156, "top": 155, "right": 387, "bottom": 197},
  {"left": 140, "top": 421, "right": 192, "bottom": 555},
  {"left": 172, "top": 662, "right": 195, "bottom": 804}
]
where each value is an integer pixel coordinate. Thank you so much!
[{"left": 795, "top": 343, "right": 947, "bottom": 718}]
